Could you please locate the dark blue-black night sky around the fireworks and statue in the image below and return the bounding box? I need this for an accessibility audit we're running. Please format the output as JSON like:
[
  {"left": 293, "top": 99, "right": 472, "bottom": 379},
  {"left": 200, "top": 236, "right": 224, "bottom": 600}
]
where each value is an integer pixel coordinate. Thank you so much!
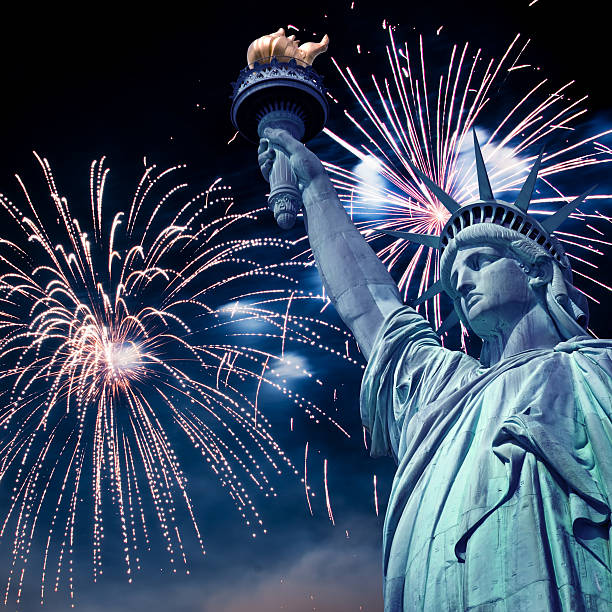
[{"left": 0, "top": 0, "right": 612, "bottom": 612}]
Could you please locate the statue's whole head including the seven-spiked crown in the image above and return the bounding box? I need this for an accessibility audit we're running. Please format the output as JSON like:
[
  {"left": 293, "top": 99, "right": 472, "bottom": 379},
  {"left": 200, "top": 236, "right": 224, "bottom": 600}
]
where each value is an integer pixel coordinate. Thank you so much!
[{"left": 390, "top": 134, "right": 588, "bottom": 362}]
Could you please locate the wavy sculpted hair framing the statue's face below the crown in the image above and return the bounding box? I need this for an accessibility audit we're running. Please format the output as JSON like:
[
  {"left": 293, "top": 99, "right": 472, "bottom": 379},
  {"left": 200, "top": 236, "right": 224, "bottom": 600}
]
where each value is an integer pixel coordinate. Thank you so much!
[{"left": 440, "top": 223, "right": 589, "bottom": 360}]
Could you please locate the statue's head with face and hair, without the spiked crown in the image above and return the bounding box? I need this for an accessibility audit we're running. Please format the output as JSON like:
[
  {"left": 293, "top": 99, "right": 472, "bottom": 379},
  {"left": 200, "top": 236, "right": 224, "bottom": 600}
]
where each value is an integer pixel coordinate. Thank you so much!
[{"left": 440, "top": 225, "right": 588, "bottom": 350}]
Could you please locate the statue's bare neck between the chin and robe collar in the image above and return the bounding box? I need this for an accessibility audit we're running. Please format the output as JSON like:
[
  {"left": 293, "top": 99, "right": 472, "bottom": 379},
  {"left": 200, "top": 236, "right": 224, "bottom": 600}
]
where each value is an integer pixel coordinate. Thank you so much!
[{"left": 485, "top": 303, "right": 563, "bottom": 366}]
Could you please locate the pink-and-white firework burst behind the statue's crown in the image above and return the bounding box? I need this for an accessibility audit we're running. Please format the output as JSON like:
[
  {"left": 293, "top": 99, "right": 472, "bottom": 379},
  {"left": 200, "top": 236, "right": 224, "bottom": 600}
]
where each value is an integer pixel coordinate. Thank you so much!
[{"left": 325, "top": 24, "right": 612, "bottom": 340}]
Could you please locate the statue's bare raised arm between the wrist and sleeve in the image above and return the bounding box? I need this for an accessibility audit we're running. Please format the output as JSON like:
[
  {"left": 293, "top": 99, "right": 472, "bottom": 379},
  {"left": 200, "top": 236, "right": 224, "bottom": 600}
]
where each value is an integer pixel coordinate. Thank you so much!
[{"left": 302, "top": 175, "right": 402, "bottom": 358}]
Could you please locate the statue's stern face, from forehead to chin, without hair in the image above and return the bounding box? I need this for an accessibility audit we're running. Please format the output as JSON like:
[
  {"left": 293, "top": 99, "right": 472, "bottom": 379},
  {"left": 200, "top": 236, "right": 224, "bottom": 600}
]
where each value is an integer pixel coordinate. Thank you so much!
[{"left": 451, "top": 246, "right": 537, "bottom": 338}]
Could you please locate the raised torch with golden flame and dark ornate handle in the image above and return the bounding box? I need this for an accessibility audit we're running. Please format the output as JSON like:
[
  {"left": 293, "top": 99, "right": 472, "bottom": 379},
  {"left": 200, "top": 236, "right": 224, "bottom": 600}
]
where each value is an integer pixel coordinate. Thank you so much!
[{"left": 231, "top": 28, "right": 329, "bottom": 229}]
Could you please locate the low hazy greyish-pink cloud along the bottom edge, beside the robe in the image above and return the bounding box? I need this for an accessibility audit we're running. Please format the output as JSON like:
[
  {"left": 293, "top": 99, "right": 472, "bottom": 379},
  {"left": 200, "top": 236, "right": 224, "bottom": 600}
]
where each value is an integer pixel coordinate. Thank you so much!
[{"left": 34, "top": 530, "right": 383, "bottom": 612}]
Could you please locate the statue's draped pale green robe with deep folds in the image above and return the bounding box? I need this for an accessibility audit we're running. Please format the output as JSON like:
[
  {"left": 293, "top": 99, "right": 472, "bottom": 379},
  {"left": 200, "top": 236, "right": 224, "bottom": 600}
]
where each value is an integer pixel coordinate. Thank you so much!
[{"left": 361, "top": 308, "right": 612, "bottom": 612}]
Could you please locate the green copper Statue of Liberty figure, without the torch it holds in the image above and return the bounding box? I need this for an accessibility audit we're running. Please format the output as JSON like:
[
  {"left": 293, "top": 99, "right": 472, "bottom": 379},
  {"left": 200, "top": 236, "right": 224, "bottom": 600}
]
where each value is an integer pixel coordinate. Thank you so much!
[{"left": 259, "top": 129, "right": 612, "bottom": 612}]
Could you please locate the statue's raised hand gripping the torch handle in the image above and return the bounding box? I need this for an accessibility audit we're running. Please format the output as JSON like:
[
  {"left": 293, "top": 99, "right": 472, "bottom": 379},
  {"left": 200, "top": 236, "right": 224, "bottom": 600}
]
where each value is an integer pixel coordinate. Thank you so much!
[{"left": 258, "top": 128, "right": 325, "bottom": 191}]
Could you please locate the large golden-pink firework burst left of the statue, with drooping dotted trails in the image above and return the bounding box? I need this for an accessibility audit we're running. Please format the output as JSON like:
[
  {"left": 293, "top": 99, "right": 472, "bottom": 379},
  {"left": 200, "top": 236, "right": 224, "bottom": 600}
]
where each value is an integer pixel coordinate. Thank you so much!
[{"left": 0, "top": 156, "right": 361, "bottom": 603}]
